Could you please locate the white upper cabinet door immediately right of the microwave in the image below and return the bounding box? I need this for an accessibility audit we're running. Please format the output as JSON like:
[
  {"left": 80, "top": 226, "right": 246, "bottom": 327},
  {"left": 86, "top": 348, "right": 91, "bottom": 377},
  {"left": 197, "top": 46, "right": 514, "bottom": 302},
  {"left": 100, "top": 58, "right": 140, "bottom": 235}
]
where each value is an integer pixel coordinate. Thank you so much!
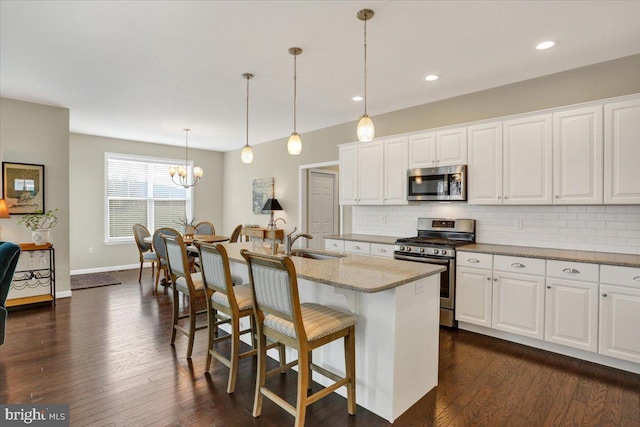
[{"left": 467, "top": 122, "right": 502, "bottom": 205}]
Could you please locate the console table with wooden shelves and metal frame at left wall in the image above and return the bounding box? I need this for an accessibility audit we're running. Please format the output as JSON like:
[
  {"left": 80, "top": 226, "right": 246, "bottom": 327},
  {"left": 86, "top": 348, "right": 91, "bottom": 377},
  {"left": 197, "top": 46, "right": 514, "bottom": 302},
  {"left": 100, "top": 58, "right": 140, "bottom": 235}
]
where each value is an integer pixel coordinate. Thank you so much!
[{"left": 7, "top": 243, "right": 56, "bottom": 308}]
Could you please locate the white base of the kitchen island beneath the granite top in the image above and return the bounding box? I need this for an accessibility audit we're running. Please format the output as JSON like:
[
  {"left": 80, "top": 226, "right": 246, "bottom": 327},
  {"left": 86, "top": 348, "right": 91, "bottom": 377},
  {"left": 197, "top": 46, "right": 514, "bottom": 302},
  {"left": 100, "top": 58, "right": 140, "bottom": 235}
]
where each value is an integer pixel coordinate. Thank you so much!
[{"left": 231, "top": 263, "right": 440, "bottom": 422}]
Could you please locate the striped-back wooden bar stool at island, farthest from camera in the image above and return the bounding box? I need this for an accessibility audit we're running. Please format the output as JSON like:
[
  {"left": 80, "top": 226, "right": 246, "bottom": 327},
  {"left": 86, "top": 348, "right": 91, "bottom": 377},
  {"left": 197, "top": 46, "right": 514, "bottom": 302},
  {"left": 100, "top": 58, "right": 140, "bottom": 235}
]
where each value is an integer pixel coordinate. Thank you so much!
[{"left": 161, "top": 234, "right": 207, "bottom": 359}]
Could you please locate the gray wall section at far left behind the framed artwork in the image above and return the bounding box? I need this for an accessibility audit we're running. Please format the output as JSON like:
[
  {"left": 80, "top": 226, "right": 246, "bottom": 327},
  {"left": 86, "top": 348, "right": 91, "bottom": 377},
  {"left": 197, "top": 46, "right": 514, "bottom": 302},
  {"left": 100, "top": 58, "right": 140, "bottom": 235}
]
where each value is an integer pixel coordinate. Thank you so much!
[{"left": 0, "top": 98, "right": 70, "bottom": 293}]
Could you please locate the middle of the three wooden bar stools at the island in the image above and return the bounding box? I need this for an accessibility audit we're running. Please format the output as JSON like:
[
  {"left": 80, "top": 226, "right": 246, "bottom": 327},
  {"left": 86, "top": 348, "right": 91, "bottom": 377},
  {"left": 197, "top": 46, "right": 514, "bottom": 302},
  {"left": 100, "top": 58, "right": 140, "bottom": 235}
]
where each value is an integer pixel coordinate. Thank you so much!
[{"left": 196, "top": 243, "right": 285, "bottom": 394}]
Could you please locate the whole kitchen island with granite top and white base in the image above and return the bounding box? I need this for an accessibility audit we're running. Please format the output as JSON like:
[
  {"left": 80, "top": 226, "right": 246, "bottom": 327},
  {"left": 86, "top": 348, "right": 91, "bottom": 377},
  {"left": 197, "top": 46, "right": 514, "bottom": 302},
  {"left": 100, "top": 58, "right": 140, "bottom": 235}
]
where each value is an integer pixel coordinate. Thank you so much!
[{"left": 216, "top": 242, "right": 444, "bottom": 422}]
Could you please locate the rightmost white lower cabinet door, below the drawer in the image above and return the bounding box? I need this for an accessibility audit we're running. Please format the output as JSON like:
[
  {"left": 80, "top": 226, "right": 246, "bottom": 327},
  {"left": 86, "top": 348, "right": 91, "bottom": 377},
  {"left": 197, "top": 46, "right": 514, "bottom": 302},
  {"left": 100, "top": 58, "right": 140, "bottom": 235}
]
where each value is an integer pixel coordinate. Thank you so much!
[{"left": 599, "top": 285, "right": 640, "bottom": 363}]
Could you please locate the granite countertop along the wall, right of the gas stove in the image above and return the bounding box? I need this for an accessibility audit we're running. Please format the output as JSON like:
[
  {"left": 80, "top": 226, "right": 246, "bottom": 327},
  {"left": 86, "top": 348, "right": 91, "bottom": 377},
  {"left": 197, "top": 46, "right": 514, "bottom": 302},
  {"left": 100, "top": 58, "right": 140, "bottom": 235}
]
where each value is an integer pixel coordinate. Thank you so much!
[{"left": 457, "top": 243, "right": 640, "bottom": 267}]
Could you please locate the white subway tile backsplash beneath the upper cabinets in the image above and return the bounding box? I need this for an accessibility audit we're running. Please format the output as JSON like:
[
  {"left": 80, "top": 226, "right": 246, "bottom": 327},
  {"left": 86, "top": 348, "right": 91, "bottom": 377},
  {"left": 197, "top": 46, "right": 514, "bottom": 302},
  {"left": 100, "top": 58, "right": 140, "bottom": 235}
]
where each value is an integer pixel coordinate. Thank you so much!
[{"left": 352, "top": 203, "right": 640, "bottom": 255}]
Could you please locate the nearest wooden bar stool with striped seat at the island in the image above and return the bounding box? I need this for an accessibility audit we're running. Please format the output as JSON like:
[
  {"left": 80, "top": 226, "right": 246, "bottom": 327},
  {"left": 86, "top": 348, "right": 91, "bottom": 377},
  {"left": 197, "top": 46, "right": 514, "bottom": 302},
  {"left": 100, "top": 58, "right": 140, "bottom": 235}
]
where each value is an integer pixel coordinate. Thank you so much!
[{"left": 240, "top": 249, "right": 357, "bottom": 426}]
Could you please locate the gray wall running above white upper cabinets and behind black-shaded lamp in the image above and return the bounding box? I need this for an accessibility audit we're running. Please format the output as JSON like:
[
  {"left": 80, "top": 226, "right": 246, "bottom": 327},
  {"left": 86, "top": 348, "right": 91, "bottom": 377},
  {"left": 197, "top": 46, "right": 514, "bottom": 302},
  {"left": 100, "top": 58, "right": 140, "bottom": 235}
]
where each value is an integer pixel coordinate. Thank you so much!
[{"left": 223, "top": 55, "right": 640, "bottom": 237}]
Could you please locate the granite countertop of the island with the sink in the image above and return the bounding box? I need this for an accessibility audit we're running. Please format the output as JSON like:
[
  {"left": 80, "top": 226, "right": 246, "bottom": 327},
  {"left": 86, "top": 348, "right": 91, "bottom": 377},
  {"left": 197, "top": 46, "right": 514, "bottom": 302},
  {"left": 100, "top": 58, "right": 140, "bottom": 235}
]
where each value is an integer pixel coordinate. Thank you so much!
[{"left": 222, "top": 242, "right": 445, "bottom": 293}]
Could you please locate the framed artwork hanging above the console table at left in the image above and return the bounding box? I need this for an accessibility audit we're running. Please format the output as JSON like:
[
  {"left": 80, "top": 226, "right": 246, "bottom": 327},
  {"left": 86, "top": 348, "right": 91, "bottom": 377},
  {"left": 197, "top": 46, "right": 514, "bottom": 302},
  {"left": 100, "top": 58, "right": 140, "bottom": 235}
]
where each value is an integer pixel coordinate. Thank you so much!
[{"left": 2, "top": 162, "right": 44, "bottom": 215}]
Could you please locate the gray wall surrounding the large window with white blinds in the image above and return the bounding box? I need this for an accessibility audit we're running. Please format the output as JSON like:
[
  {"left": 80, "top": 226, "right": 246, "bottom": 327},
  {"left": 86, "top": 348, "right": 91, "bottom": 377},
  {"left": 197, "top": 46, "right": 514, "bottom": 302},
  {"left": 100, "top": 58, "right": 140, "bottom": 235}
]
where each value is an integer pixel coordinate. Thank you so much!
[{"left": 69, "top": 133, "right": 223, "bottom": 273}]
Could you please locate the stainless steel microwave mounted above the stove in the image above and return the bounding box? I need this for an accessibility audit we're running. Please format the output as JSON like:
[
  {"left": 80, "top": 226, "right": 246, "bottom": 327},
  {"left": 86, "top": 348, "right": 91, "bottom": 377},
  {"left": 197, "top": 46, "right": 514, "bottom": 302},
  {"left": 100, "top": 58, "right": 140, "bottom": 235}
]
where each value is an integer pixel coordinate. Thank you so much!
[{"left": 407, "top": 165, "right": 467, "bottom": 201}]
